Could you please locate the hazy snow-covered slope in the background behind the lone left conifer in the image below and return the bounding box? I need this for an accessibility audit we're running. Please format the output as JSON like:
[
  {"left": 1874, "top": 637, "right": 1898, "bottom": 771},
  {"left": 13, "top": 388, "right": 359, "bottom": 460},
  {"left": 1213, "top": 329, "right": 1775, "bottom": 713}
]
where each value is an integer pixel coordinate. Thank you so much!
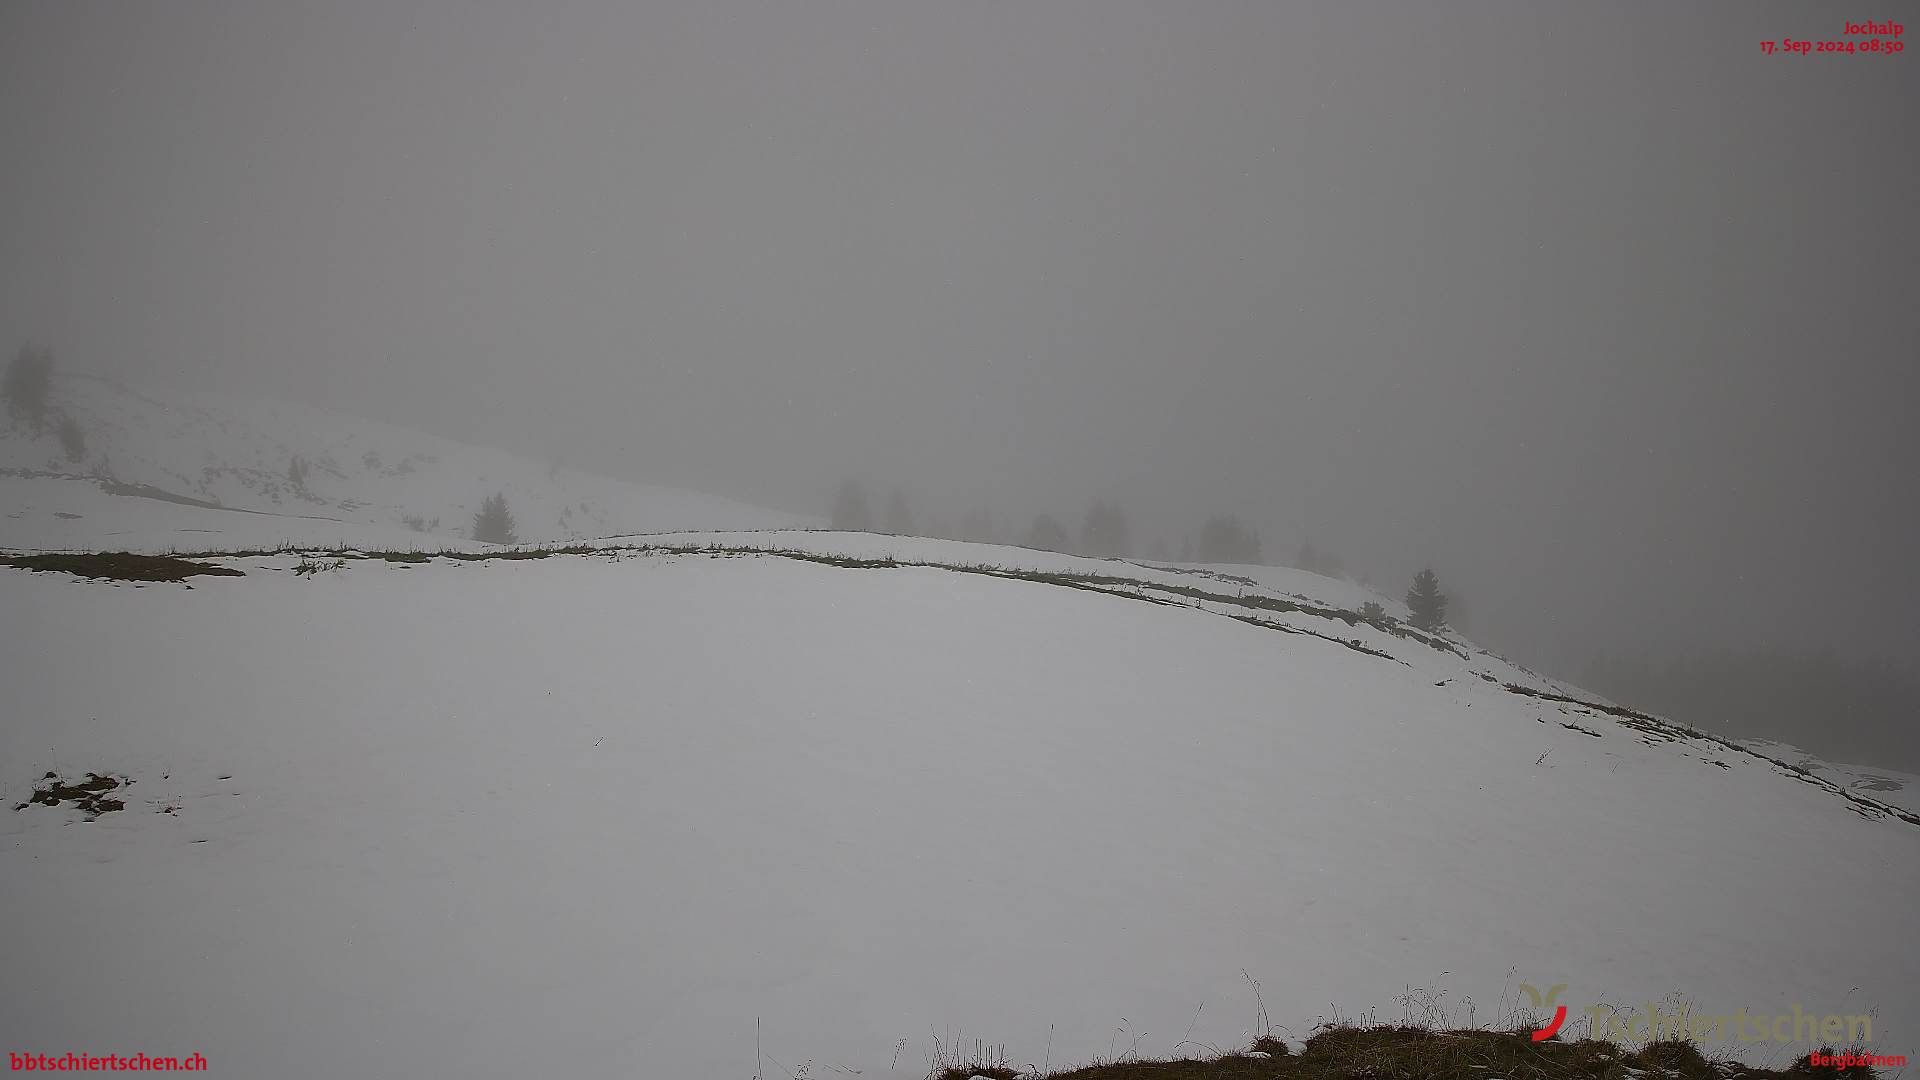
[{"left": 0, "top": 375, "right": 812, "bottom": 550}]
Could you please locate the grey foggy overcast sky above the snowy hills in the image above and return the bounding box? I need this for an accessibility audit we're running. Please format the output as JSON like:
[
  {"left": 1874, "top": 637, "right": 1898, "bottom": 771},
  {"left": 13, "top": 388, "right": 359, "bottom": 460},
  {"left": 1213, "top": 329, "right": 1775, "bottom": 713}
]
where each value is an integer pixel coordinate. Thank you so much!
[{"left": 0, "top": 0, "right": 1920, "bottom": 669}]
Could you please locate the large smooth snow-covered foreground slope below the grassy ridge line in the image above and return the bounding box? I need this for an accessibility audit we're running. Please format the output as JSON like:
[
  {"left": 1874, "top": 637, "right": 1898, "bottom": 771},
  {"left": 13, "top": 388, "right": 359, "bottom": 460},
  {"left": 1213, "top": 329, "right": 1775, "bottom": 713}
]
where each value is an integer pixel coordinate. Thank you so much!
[{"left": 0, "top": 532, "right": 1920, "bottom": 1078}]
